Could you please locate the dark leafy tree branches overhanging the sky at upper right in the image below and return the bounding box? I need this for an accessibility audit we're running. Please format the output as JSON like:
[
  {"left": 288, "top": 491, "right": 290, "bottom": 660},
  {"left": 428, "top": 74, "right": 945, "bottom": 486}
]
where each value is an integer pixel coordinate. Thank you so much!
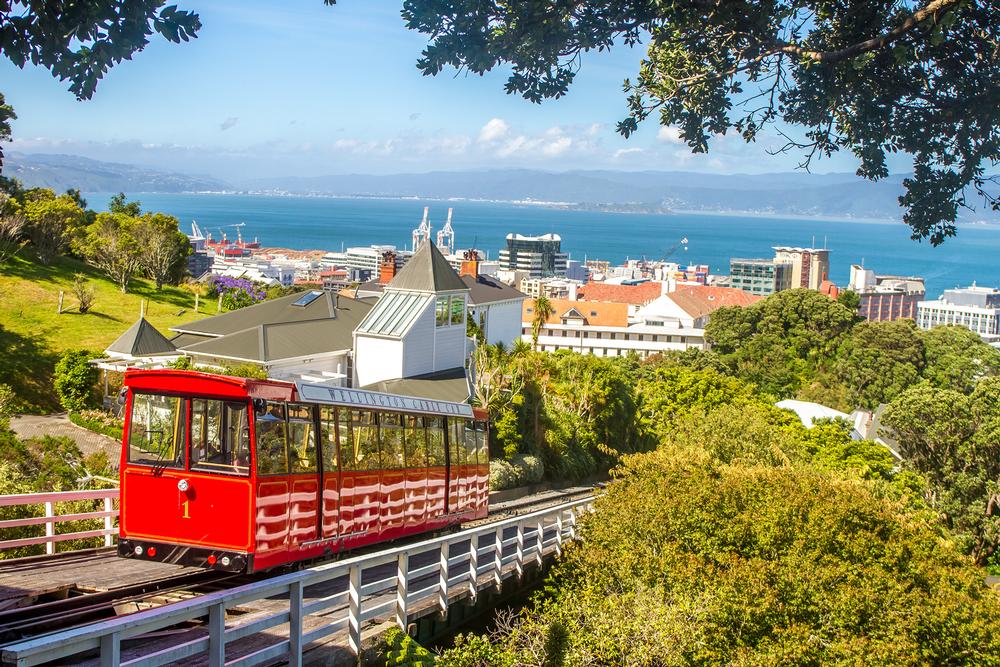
[{"left": 403, "top": 0, "right": 1000, "bottom": 245}]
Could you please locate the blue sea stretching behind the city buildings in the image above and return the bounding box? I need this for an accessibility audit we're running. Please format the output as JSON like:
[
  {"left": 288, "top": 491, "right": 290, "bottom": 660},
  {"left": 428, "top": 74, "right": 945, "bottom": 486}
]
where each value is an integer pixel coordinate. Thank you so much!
[{"left": 85, "top": 193, "right": 1000, "bottom": 297}]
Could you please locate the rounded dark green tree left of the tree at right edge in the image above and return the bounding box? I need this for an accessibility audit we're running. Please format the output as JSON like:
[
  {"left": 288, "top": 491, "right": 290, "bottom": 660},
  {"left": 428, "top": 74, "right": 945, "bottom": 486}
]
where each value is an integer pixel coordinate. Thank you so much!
[{"left": 835, "top": 320, "right": 924, "bottom": 409}]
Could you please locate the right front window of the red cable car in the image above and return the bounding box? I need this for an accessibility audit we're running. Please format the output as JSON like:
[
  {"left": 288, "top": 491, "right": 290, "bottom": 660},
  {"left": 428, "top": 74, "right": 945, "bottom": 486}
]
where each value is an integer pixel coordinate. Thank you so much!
[{"left": 191, "top": 398, "right": 250, "bottom": 475}]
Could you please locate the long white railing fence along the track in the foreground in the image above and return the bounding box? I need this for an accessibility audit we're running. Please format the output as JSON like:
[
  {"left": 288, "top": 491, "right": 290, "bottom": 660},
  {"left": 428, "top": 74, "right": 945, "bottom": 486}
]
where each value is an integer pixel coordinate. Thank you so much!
[{"left": 3, "top": 497, "right": 593, "bottom": 667}]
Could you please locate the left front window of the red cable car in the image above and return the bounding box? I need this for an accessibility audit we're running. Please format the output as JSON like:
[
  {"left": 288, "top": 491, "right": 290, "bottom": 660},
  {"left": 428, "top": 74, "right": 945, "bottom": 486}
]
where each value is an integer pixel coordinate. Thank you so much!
[{"left": 128, "top": 394, "right": 185, "bottom": 468}]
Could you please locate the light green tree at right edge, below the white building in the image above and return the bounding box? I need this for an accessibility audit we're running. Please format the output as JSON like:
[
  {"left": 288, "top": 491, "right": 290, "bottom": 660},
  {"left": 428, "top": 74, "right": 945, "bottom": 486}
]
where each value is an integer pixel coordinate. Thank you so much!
[{"left": 920, "top": 326, "right": 1000, "bottom": 394}]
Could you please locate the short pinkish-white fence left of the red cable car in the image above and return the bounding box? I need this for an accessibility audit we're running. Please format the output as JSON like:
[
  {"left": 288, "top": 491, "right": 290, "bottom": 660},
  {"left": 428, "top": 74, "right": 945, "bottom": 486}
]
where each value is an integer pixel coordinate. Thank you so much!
[{"left": 0, "top": 489, "right": 118, "bottom": 554}]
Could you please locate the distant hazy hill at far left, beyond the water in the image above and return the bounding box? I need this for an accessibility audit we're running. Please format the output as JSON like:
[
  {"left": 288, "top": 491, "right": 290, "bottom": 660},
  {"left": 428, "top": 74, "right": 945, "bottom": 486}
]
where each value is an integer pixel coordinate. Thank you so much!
[{"left": 3, "top": 153, "right": 233, "bottom": 193}]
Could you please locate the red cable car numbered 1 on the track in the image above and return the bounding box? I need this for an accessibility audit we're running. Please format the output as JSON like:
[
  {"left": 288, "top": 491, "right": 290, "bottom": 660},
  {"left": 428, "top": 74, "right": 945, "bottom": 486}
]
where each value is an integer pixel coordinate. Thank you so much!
[{"left": 118, "top": 370, "right": 489, "bottom": 572}]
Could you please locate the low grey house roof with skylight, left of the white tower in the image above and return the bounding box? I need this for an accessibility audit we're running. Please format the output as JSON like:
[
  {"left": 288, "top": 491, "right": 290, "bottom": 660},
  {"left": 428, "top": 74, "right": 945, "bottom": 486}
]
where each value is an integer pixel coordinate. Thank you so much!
[{"left": 177, "top": 294, "right": 372, "bottom": 363}]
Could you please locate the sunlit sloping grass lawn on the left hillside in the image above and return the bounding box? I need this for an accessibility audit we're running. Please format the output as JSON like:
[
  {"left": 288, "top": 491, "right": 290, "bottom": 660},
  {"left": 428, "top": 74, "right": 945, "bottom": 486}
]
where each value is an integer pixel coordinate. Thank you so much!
[{"left": 0, "top": 251, "right": 215, "bottom": 412}]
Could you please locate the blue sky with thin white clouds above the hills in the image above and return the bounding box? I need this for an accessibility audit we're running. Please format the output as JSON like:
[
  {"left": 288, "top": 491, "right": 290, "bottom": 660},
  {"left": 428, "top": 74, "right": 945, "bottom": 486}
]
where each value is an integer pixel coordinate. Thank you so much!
[{"left": 0, "top": 0, "right": 906, "bottom": 182}]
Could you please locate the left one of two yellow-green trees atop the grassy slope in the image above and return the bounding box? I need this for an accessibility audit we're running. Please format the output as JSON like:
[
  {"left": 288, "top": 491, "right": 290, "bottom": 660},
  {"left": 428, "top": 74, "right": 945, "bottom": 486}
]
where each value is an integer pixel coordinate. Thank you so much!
[{"left": 78, "top": 213, "right": 144, "bottom": 293}]
